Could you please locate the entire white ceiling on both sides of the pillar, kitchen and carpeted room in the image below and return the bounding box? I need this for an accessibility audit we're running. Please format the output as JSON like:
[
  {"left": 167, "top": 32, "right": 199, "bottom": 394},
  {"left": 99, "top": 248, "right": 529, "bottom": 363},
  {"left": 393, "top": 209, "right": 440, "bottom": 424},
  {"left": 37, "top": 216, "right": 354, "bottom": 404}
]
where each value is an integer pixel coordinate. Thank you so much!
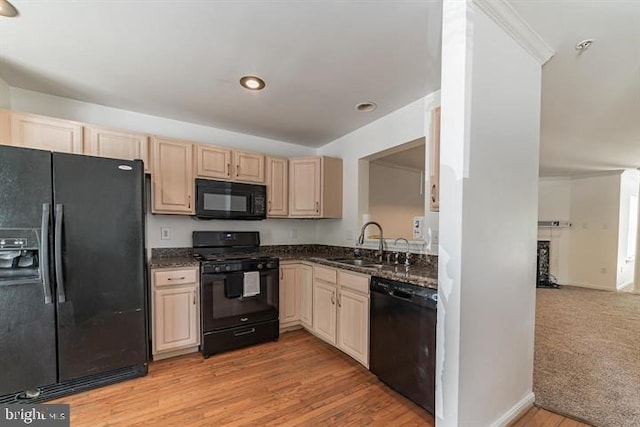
[{"left": 0, "top": 0, "right": 640, "bottom": 176}]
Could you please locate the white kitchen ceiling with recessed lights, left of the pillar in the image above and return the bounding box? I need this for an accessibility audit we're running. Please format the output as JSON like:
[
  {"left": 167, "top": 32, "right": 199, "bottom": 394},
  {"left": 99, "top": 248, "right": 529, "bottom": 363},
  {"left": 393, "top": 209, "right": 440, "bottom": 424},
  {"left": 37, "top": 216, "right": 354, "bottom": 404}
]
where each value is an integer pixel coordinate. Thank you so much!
[{"left": 0, "top": 0, "right": 442, "bottom": 146}]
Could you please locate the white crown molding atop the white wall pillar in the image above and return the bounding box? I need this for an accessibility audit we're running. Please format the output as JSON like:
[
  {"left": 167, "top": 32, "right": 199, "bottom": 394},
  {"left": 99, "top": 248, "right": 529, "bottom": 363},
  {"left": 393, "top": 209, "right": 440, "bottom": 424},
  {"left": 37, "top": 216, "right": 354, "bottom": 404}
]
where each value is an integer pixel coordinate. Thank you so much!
[{"left": 473, "top": 0, "right": 555, "bottom": 65}]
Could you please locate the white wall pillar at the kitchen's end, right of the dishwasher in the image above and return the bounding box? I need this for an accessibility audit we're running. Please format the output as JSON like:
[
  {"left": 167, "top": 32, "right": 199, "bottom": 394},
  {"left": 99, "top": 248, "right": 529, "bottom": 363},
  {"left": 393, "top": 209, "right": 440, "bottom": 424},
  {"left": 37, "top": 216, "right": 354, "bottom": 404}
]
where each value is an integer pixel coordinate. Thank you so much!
[{"left": 436, "top": 1, "right": 541, "bottom": 426}]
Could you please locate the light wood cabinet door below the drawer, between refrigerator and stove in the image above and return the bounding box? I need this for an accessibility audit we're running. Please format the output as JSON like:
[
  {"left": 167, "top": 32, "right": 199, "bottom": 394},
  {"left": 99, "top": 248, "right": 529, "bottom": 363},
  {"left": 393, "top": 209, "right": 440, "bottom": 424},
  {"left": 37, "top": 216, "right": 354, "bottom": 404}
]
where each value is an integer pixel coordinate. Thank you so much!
[{"left": 153, "top": 285, "right": 200, "bottom": 354}]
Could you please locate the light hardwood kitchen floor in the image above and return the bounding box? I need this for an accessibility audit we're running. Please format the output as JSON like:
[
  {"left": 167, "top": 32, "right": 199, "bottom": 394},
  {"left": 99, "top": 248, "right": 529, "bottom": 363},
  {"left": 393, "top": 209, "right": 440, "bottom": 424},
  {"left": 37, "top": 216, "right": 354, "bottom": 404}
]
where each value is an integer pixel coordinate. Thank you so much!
[{"left": 52, "top": 331, "right": 585, "bottom": 427}]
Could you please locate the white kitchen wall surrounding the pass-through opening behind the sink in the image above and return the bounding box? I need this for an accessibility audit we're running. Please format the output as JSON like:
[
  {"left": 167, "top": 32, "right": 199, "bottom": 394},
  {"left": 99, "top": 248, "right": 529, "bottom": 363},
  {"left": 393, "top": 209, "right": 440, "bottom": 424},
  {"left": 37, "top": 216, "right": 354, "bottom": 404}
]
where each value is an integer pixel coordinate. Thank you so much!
[{"left": 318, "top": 91, "right": 440, "bottom": 253}]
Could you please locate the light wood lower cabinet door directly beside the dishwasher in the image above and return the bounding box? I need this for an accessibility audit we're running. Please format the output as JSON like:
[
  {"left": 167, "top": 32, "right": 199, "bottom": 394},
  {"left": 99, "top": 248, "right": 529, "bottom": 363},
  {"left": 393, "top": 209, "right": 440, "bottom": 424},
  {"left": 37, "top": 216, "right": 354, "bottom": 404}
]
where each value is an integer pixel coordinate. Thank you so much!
[{"left": 338, "top": 288, "right": 369, "bottom": 367}]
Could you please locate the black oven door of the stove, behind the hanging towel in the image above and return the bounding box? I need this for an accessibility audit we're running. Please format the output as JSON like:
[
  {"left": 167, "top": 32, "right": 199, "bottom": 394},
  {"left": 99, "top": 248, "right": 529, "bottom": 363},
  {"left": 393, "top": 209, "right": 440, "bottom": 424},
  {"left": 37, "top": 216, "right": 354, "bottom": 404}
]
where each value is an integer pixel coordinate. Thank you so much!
[{"left": 200, "top": 269, "right": 278, "bottom": 333}]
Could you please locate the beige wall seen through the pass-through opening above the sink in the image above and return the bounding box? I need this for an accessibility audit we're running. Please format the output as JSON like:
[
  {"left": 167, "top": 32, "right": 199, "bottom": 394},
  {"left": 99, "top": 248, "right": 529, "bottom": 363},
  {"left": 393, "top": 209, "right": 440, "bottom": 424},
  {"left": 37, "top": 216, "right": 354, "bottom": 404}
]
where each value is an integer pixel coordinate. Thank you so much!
[{"left": 369, "top": 163, "right": 425, "bottom": 240}]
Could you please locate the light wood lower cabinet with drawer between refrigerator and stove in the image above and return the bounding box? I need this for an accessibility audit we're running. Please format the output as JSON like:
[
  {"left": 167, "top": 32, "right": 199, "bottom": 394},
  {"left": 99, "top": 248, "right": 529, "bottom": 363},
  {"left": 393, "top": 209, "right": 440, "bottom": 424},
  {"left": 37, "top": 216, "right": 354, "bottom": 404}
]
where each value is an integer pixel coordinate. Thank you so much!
[{"left": 151, "top": 267, "right": 200, "bottom": 360}]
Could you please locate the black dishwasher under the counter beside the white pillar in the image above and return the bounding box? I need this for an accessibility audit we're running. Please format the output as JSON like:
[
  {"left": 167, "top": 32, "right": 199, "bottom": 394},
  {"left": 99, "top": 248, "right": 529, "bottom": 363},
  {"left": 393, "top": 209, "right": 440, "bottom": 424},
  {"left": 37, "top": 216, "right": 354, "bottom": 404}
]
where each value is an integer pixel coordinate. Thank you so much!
[{"left": 369, "top": 277, "right": 438, "bottom": 414}]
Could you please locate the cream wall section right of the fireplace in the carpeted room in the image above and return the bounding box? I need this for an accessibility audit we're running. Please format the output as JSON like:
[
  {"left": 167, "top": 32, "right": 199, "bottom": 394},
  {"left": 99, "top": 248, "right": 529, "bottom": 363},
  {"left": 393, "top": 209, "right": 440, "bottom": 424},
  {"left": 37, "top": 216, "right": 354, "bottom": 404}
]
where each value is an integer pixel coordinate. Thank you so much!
[{"left": 569, "top": 172, "right": 620, "bottom": 290}]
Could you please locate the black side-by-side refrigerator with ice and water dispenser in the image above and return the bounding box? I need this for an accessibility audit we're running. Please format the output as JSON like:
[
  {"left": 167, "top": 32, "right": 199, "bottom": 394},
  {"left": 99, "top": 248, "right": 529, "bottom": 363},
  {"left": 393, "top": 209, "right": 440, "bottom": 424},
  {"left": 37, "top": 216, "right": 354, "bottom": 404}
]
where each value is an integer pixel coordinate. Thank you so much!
[{"left": 0, "top": 146, "right": 148, "bottom": 403}]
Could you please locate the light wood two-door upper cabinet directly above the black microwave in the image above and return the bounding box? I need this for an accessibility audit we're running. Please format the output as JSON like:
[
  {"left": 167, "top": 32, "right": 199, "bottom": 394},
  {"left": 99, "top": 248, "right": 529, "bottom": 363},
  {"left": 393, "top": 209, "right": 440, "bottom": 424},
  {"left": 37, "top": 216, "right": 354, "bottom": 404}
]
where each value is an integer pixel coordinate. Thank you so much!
[{"left": 194, "top": 144, "right": 265, "bottom": 184}]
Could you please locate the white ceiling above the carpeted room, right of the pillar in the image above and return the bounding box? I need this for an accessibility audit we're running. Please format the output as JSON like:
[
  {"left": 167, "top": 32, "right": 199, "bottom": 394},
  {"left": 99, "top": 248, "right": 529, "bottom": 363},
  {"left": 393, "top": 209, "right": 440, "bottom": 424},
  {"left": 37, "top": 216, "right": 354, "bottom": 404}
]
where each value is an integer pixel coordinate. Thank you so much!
[{"left": 511, "top": 0, "right": 640, "bottom": 176}]
